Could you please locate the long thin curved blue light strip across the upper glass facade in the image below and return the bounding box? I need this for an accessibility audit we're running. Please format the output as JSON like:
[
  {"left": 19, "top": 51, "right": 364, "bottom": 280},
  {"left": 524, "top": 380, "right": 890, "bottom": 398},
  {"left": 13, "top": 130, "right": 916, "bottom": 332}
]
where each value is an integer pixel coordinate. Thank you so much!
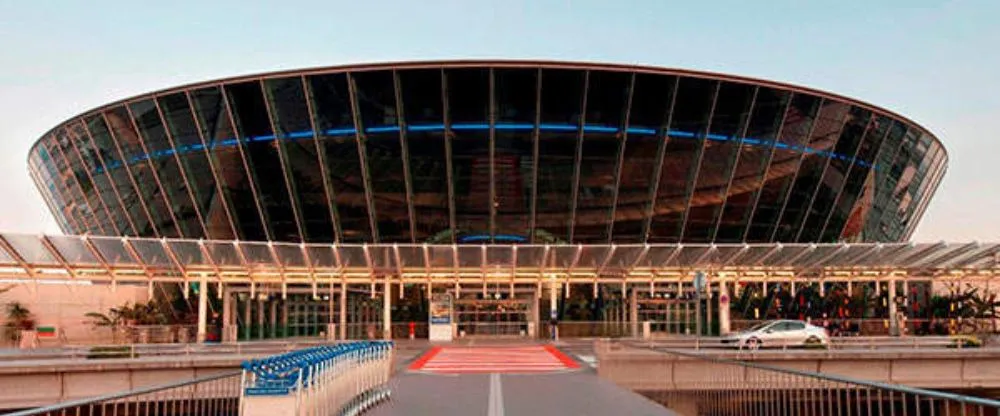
[{"left": 92, "top": 123, "right": 879, "bottom": 173}]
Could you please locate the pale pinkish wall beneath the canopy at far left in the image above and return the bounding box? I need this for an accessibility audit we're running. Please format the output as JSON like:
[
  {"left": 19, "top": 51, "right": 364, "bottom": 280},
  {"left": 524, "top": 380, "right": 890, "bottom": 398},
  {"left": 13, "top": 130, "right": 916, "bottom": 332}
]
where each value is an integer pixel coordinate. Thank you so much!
[{"left": 0, "top": 284, "right": 149, "bottom": 346}]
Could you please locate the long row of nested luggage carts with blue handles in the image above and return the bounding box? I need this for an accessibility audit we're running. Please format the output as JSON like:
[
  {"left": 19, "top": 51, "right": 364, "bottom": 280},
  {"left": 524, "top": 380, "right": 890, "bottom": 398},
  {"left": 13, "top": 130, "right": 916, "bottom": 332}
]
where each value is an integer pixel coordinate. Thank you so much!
[{"left": 240, "top": 341, "right": 393, "bottom": 416}]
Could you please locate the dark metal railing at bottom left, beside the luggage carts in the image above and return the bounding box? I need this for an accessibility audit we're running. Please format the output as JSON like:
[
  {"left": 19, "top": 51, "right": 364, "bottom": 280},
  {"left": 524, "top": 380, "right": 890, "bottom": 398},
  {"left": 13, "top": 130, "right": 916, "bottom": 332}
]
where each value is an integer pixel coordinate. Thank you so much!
[{"left": 8, "top": 371, "right": 240, "bottom": 416}]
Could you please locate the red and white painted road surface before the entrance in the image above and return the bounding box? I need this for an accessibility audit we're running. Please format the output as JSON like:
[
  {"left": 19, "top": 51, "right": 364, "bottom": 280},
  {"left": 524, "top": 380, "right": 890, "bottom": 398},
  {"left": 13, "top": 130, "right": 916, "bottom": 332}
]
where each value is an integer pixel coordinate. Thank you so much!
[{"left": 409, "top": 345, "right": 580, "bottom": 374}]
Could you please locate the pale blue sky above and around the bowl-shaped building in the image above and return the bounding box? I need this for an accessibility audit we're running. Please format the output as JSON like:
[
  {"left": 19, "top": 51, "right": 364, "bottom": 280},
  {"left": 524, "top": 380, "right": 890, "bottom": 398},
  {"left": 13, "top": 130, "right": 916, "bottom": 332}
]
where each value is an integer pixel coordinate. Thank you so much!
[{"left": 0, "top": 0, "right": 1000, "bottom": 241}]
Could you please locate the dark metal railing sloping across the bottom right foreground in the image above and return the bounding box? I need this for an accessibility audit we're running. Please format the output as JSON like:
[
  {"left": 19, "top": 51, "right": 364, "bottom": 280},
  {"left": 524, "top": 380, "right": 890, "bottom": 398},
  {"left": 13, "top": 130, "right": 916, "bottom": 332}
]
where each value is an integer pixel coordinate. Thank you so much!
[{"left": 639, "top": 347, "right": 1000, "bottom": 416}]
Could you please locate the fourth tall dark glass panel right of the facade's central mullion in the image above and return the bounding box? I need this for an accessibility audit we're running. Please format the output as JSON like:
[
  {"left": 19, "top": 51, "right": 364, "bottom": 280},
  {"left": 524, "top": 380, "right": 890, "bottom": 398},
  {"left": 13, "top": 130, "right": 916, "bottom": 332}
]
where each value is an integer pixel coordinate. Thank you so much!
[{"left": 612, "top": 74, "right": 677, "bottom": 242}]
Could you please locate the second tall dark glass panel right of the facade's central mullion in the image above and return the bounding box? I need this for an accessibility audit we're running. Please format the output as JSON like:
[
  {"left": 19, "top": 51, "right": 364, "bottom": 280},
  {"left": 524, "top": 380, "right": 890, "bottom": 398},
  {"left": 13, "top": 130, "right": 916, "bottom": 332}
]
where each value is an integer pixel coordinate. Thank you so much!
[{"left": 535, "top": 69, "right": 586, "bottom": 243}]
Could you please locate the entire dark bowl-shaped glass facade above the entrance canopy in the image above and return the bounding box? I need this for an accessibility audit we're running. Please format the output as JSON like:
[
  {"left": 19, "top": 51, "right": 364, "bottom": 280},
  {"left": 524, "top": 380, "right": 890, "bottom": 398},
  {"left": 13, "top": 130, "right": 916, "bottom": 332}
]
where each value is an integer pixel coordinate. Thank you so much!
[{"left": 28, "top": 62, "right": 948, "bottom": 244}]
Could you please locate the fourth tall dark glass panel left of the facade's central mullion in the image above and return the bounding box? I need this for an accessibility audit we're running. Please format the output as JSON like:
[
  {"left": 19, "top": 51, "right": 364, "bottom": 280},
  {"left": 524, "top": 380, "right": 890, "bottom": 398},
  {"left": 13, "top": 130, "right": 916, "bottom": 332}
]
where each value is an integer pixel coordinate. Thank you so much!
[{"left": 306, "top": 74, "right": 373, "bottom": 242}]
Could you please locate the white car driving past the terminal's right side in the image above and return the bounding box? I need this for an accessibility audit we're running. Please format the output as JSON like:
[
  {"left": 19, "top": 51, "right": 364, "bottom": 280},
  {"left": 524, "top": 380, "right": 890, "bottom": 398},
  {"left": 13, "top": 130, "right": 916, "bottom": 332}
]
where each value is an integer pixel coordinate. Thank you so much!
[{"left": 722, "top": 320, "right": 830, "bottom": 349}]
